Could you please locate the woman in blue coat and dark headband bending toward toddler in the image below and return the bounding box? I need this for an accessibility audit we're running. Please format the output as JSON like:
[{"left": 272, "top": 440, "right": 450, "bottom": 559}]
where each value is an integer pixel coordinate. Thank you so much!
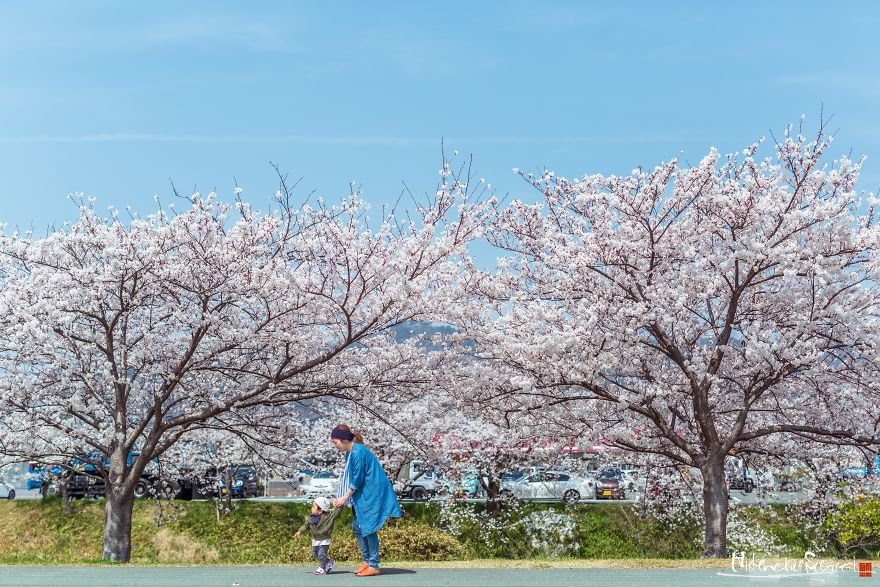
[{"left": 330, "top": 424, "right": 401, "bottom": 577}]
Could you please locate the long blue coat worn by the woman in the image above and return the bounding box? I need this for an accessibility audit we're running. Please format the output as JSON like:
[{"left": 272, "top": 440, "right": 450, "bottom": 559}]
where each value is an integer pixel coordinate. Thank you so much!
[{"left": 347, "top": 443, "right": 402, "bottom": 535}]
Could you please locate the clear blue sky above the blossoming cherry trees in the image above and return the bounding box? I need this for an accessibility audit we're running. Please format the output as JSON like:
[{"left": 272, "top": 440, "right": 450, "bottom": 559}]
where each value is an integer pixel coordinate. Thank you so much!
[{"left": 0, "top": 0, "right": 880, "bottom": 233}]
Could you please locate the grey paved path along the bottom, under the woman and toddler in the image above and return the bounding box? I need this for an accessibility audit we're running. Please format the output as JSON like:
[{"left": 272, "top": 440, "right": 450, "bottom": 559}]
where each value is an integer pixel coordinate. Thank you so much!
[{"left": 0, "top": 566, "right": 880, "bottom": 587}]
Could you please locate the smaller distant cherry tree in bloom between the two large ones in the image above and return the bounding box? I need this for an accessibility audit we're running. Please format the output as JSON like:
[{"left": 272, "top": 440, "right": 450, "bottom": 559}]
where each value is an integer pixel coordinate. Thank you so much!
[{"left": 323, "top": 352, "right": 588, "bottom": 516}]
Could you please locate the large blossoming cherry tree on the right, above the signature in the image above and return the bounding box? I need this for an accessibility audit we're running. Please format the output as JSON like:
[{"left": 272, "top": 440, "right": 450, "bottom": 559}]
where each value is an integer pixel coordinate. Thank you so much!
[{"left": 458, "top": 123, "right": 880, "bottom": 556}]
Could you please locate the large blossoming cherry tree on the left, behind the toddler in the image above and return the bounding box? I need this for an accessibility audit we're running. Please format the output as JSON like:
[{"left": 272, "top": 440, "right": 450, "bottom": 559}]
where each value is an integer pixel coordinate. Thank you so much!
[{"left": 0, "top": 166, "right": 483, "bottom": 562}]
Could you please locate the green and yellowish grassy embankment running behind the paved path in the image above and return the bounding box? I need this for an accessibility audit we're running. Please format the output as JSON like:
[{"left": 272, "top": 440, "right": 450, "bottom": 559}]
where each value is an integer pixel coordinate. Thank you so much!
[{"left": 0, "top": 499, "right": 868, "bottom": 566}]
